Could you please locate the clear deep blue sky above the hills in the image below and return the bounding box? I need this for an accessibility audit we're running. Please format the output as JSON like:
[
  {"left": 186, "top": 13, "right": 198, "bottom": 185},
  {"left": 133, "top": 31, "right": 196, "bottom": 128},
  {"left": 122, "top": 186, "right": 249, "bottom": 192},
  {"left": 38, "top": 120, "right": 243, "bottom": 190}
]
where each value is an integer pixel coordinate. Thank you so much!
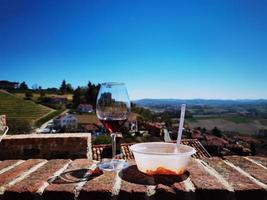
[{"left": 0, "top": 0, "right": 267, "bottom": 99}]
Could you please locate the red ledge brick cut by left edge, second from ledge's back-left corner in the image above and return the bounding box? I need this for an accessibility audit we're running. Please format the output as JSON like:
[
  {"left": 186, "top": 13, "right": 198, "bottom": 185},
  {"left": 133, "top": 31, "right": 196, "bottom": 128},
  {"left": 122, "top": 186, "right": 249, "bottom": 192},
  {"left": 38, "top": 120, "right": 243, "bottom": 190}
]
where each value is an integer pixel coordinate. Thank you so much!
[{"left": 0, "top": 159, "right": 45, "bottom": 186}]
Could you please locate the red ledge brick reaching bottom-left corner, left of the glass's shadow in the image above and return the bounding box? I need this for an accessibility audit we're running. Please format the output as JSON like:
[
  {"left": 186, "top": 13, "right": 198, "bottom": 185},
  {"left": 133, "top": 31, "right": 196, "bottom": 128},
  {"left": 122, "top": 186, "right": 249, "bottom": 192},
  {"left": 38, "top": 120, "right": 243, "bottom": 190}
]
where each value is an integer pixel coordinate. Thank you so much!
[{"left": 4, "top": 160, "right": 70, "bottom": 200}]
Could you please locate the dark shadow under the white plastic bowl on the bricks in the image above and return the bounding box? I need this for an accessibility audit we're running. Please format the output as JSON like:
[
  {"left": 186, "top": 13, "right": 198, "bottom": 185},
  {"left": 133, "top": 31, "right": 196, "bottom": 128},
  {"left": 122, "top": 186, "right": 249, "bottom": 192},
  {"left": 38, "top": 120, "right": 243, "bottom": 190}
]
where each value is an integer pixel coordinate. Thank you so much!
[{"left": 119, "top": 165, "right": 190, "bottom": 186}]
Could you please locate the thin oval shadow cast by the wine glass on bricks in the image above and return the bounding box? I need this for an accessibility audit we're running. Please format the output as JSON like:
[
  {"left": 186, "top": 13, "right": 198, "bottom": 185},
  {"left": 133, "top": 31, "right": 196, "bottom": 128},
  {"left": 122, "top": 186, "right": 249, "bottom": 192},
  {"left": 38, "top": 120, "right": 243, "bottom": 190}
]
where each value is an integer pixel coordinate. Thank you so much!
[{"left": 48, "top": 169, "right": 103, "bottom": 184}]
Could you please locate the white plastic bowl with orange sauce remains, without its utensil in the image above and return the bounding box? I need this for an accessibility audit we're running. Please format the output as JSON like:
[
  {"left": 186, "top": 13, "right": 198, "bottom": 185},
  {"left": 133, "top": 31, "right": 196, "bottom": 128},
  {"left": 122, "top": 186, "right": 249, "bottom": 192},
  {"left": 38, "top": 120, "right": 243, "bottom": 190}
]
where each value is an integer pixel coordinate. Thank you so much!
[{"left": 130, "top": 142, "right": 196, "bottom": 175}]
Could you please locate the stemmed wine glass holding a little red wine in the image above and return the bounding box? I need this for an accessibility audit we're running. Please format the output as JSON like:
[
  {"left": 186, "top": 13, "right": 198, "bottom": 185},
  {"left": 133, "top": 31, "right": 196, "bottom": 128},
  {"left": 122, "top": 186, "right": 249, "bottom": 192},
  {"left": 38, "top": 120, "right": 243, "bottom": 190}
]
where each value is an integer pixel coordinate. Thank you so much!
[{"left": 96, "top": 82, "right": 131, "bottom": 171}]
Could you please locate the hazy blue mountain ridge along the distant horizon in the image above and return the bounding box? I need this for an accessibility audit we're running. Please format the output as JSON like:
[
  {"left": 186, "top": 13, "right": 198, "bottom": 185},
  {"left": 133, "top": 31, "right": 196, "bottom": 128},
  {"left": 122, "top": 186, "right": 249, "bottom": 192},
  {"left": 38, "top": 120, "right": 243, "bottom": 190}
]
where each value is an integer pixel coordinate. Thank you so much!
[{"left": 134, "top": 99, "right": 267, "bottom": 107}]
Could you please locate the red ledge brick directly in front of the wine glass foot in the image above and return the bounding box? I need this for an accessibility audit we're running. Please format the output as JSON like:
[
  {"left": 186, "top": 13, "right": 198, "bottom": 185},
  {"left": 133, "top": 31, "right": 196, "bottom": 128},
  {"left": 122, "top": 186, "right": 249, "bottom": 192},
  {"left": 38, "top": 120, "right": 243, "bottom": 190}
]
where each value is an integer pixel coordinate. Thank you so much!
[{"left": 78, "top": 172, "right": 116, "bottom": 200}]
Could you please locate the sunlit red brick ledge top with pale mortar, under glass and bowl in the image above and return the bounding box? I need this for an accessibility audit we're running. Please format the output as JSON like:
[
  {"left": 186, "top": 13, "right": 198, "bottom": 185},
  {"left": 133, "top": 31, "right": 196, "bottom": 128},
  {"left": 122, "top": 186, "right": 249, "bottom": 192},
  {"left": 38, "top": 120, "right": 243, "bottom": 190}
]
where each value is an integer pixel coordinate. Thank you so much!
[{"left": 0, "top": 156, "right": 267, "bottom": 200}]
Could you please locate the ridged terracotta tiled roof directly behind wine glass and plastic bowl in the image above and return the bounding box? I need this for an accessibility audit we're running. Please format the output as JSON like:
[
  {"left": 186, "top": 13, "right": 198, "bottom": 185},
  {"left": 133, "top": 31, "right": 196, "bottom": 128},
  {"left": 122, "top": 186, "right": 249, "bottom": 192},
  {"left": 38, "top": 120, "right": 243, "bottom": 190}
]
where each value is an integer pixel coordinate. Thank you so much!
[{"left": 92, "top": 139, "right": 211, "bottom": 160}]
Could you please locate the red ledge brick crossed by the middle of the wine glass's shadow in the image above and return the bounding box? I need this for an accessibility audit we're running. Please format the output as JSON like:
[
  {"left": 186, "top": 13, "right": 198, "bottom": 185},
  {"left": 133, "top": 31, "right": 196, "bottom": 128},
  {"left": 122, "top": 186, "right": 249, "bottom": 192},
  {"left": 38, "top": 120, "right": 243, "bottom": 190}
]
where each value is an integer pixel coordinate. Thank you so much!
[{"left": 43, "top": 159, "right": 92, "bottom": 200}]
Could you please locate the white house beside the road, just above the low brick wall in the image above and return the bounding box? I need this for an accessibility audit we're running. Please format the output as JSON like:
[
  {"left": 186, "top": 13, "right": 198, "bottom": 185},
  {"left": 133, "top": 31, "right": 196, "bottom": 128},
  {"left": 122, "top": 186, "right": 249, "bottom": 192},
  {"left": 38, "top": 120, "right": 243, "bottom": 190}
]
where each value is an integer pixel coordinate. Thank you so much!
[{"left": 54, "top": 113, "right": 78, "bottom": 128}]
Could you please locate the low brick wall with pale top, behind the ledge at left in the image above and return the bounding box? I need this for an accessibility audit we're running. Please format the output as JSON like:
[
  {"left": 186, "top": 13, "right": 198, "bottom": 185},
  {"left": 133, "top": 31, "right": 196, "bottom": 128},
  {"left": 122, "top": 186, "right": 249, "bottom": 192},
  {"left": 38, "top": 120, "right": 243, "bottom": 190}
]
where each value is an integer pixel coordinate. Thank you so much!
[{"left": 0, "top": 133, "right": 92, "bottom": 160}]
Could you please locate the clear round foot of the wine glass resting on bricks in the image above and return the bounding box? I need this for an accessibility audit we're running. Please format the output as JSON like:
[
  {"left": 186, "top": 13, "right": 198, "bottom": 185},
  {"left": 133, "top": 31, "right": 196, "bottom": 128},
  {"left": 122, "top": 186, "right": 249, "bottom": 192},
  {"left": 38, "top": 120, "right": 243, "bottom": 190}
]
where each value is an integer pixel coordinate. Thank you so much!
[{"left": 98, "top": 159, "right": 128, "bottom": 171}]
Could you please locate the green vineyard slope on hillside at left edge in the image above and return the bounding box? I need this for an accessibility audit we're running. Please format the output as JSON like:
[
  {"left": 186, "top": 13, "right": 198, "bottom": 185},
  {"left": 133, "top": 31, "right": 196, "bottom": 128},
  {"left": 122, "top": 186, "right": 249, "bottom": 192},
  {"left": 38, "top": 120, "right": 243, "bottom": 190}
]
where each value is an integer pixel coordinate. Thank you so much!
[{"left": 0, "top": 92, "right": 54, "bottom": 122}]
